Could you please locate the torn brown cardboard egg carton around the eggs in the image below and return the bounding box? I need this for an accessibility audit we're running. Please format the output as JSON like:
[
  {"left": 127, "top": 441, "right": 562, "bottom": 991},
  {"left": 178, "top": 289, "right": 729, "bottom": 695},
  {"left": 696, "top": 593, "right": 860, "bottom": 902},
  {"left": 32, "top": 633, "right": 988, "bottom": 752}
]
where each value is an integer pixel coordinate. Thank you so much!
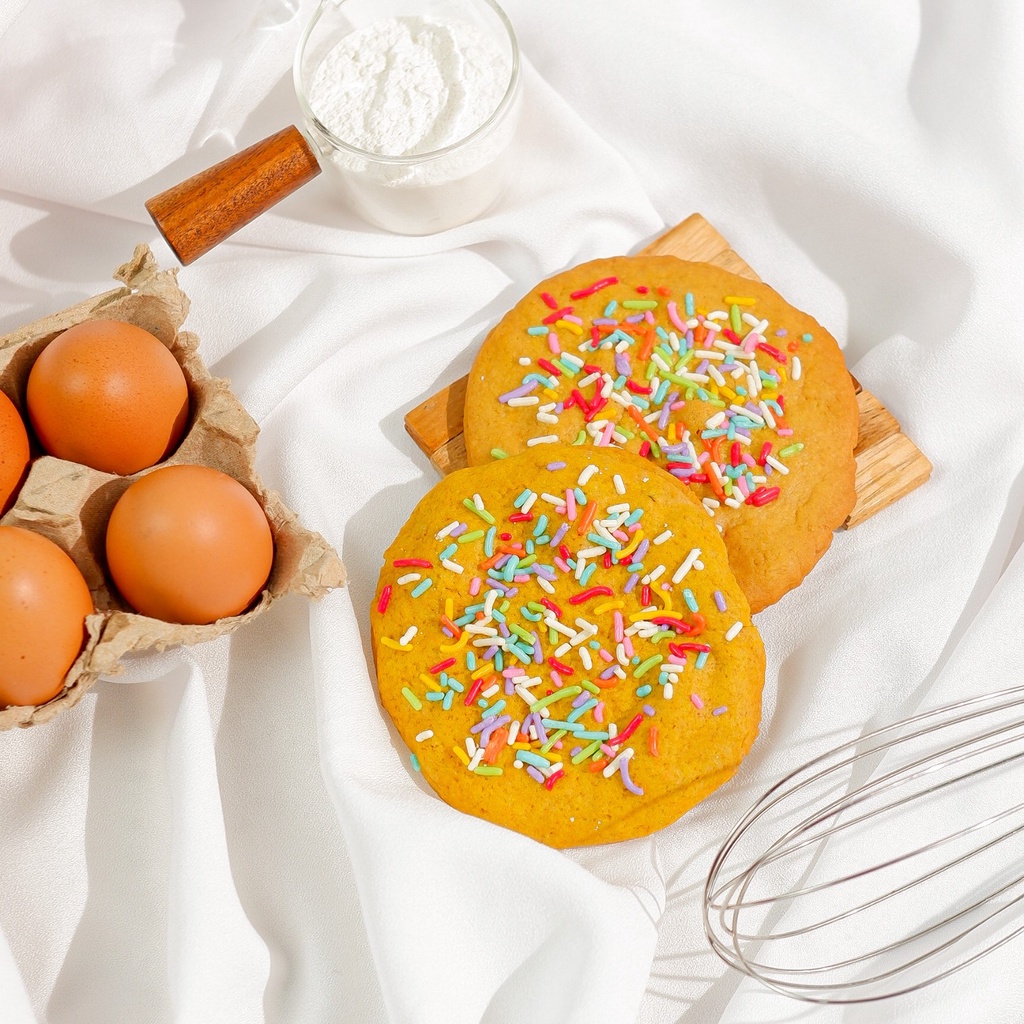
[{"left": 0, "top": 245, "right": 345, "bottom": 730}]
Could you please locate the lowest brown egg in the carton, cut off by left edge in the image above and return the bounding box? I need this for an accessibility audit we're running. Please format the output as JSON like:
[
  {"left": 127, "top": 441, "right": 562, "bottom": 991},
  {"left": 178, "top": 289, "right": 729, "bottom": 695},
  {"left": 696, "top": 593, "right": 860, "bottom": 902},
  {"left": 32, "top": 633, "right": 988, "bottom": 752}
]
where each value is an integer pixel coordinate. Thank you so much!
[{"left": 0, "top": 526, "right": 93, "bottom": 707}]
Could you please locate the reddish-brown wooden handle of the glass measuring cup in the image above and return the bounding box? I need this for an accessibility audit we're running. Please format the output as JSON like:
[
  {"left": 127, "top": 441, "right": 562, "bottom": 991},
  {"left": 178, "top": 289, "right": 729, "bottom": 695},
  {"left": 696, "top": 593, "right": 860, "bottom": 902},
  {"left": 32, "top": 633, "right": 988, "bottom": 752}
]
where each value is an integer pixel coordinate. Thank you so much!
[{"left": 145, "top": 125, "right": 321, "bottom": 265}]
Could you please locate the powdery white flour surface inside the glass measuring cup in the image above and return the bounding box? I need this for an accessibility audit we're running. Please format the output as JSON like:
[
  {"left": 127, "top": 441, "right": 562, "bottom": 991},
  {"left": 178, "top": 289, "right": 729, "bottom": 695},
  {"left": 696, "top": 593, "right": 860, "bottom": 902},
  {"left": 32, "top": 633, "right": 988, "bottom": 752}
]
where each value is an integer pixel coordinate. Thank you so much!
[{"left": 308, "top": 16, "right": 510, "bottom": 157}]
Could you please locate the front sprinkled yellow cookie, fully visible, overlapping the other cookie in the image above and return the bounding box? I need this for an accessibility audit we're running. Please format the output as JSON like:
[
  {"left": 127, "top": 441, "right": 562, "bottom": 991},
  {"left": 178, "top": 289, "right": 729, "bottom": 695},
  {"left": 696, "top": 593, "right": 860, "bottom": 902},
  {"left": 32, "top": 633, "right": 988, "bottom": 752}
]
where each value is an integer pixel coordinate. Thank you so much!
[{"left": 371, "top": 444, "right": 764, "bottom": 847}]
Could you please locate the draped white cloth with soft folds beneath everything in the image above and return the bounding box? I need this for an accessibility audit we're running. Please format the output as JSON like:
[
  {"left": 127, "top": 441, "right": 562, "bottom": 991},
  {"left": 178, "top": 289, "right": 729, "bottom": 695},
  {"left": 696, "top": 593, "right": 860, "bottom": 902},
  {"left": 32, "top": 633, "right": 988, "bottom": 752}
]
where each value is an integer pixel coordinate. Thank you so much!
[{"left": 0, "top": 0, "right": 1024, "bottom": 1024}]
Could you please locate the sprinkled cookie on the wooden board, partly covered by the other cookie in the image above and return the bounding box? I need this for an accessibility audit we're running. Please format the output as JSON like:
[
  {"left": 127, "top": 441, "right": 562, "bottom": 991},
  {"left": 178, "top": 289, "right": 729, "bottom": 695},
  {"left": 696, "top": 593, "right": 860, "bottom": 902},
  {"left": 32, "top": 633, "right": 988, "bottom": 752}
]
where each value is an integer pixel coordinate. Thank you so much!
[{"left": 465, "top": 256, "right": 857, "bottom": 611}]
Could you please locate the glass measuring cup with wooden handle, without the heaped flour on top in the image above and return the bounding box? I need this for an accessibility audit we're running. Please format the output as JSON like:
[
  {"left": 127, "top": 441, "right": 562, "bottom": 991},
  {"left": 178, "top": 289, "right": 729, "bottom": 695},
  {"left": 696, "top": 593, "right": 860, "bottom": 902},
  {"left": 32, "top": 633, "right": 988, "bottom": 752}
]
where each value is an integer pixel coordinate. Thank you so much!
[{"left": 145, "top": 0, "right": 522, "bottom": 264}]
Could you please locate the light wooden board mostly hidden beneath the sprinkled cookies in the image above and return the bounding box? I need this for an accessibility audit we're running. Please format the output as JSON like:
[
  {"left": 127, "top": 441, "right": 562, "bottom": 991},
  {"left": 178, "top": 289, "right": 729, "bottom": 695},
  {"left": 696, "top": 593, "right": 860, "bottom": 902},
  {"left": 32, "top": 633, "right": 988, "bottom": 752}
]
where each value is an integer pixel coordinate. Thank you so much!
[{"left": 406, "top": 213, "right": 932, "bottom": 527}]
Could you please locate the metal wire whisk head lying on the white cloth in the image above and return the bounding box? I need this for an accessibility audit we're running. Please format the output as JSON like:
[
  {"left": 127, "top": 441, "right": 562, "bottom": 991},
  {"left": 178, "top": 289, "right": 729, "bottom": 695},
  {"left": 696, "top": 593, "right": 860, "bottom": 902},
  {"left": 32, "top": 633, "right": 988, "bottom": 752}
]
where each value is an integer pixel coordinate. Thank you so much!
[{"left": 705, "top": 686, "right": 1024, "bottom": 1004}]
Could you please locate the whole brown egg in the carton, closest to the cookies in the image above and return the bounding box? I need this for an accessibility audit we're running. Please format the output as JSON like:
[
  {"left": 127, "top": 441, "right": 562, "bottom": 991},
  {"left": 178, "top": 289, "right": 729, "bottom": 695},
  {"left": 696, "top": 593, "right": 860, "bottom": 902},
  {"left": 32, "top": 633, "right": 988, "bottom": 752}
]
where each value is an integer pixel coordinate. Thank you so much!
[{"left": 106, "top": 466, "right": 273, "bottom": 625}]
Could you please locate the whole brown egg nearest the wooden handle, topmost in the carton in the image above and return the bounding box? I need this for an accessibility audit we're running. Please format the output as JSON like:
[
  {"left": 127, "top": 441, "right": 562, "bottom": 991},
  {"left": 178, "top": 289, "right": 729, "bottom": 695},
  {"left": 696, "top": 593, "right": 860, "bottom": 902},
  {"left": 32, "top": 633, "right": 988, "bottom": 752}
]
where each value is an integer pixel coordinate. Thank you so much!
[{"left": 27, "top": 321, "right": 188, "bottom": 476}]
